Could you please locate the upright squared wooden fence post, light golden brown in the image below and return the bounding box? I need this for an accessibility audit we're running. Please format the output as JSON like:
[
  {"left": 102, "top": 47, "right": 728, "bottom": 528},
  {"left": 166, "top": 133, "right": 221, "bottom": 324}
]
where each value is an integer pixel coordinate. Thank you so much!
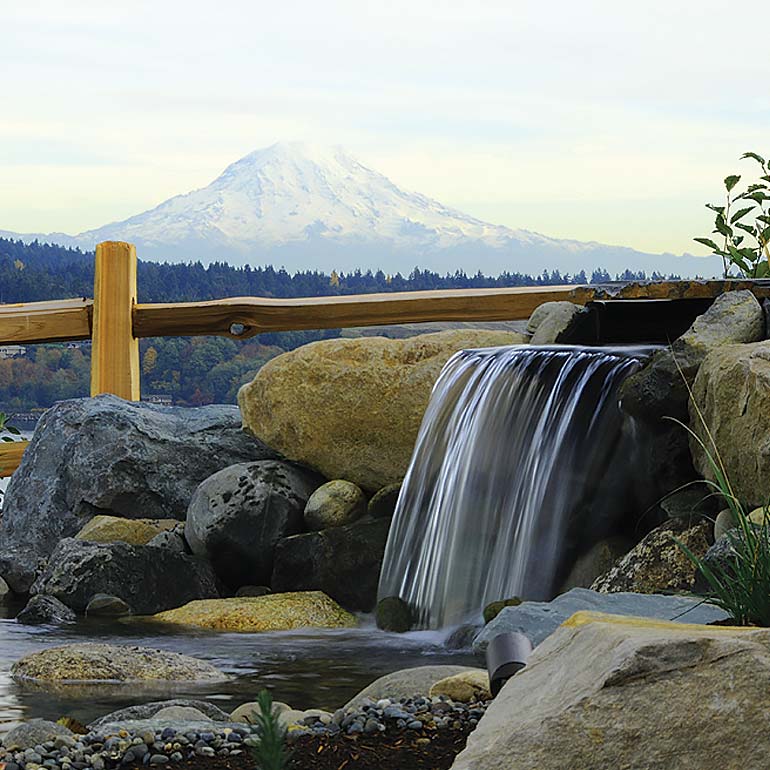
[{"left": 91, "top": 241, "right": 140, "bottom": 401}]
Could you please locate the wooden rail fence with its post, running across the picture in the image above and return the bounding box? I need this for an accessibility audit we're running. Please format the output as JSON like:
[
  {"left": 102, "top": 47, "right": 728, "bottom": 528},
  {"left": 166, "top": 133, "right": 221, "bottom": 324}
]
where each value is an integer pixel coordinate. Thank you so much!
[{"left": 0, "top": 241, "right": 770, "bottom": 477}]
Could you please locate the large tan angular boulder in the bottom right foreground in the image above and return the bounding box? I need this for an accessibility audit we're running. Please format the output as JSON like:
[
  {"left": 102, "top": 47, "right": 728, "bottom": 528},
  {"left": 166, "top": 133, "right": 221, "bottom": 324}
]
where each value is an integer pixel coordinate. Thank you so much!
[{"left": 452, "top": 612, "right": 770, "bottom": 770}]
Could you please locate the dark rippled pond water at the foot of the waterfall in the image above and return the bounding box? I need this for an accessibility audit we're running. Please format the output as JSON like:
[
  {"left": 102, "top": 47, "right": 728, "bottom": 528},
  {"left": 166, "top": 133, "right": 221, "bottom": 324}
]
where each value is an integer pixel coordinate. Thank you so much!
[{"left": 0, "top": 608, "right": 474, "bottom": 732}]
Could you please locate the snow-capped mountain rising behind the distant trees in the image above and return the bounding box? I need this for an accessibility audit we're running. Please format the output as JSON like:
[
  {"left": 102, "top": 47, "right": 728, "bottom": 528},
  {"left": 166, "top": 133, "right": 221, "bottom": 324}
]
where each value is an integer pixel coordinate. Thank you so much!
[{"left": 0, "top": 143, "right": 718, "bottom": 275}]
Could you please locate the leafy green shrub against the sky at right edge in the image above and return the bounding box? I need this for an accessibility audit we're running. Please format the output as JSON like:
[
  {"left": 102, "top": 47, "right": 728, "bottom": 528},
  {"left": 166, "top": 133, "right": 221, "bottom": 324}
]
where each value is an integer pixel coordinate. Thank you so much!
[{"left": 695, "top": 152, "right": 770, "bottom": 278}]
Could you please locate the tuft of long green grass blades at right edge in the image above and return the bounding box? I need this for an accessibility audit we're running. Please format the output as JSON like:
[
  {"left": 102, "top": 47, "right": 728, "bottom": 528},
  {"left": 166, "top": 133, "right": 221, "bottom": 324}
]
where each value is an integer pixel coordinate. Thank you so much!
[{"left": 675, "top": 393, "right": 770, "bottom": 627}]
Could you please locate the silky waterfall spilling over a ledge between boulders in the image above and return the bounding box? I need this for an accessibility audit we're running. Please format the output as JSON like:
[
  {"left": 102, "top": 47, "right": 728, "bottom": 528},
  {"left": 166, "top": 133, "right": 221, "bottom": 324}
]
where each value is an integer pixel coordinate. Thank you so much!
[{"left": 379, "top": 346, "right": 654, "bottom": 628}]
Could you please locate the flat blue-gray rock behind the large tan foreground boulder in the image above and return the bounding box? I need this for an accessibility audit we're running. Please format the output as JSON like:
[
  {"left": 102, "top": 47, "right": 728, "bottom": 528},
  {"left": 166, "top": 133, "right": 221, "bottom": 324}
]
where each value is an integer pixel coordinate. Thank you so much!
[{"left": 473, "top": 588, "right": 727, "bottom": 655}]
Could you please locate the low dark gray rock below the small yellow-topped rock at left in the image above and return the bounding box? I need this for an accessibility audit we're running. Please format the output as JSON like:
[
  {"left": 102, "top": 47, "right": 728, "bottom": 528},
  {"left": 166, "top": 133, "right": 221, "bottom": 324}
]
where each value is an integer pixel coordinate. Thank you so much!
[{"left": 32, "top": 538, "right": 219, "bottom": 615}]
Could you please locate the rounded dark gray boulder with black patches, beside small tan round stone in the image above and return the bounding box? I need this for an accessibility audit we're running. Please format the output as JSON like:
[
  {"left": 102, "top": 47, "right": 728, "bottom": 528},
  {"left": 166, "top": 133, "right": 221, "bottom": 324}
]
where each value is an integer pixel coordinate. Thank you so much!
[{"left": 185, "top": 460, "right": 323, "bottom": 589}]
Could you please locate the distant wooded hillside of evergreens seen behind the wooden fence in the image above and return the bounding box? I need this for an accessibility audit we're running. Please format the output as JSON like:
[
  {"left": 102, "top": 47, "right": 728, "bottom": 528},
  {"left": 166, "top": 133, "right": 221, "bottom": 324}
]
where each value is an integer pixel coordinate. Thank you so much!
[{"left": 0, "top": 238, "right": 672, "bottom": 410}]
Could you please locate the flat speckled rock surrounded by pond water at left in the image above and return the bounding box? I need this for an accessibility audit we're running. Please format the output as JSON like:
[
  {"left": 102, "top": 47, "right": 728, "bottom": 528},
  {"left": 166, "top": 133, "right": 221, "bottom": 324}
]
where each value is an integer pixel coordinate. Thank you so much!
[{"left": 11, "top": 643, "right": 227, "bottom": 683}]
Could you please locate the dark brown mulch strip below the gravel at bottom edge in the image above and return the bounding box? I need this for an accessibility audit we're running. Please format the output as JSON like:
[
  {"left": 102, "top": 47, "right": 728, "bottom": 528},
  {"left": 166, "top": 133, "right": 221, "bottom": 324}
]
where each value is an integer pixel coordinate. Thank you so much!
[{"left": 289, "top": 730, "right": 468, "bottom": 770}]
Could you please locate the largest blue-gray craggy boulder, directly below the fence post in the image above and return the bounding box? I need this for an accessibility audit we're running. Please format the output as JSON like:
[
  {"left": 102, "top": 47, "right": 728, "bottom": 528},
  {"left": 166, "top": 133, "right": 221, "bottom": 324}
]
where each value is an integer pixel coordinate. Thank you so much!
[{"left": 0, "top": 395, "right": 276, "bottom": 593}]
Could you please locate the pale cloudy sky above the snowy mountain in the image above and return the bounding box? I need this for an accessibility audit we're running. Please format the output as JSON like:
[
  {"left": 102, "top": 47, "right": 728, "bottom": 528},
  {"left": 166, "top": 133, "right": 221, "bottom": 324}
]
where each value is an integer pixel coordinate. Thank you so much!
[{"left": 0, "top": 0, "right": 770, "bottom": 253}]
